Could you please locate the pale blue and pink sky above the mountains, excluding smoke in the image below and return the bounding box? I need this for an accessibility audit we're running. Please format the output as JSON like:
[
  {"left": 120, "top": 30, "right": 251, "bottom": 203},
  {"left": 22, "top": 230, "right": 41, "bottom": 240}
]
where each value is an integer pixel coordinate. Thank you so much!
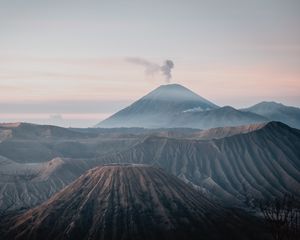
[{"left": 0, "top": 0, "right": 300, "bottom": 127}]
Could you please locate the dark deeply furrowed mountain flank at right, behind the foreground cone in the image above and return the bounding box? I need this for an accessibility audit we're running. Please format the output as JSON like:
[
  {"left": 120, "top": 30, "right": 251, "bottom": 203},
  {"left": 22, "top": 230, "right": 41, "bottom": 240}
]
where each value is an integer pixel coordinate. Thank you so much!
[{"left": 108, "top": 122, "right": 300, "bottom": 204}]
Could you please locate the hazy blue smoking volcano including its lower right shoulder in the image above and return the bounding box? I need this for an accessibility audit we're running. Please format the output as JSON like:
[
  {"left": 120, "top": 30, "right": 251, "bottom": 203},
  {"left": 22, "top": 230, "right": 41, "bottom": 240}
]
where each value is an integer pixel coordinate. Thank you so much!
[{"left": 97, "top": 84, "right": 267, "bottom": 129}]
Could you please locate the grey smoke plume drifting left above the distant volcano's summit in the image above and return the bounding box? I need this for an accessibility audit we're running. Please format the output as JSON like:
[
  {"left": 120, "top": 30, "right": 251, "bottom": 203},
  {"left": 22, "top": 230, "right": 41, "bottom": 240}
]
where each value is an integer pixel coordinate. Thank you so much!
[{"left": 126, "top": 58, "right": 174, "bottom": 83}]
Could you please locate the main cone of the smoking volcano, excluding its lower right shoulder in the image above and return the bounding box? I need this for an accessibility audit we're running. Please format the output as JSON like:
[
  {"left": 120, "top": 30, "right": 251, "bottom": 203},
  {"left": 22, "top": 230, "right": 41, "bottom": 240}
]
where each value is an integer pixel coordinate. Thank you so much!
[{"left": 97, "top": 84, "right": 218, "bottom": 128}]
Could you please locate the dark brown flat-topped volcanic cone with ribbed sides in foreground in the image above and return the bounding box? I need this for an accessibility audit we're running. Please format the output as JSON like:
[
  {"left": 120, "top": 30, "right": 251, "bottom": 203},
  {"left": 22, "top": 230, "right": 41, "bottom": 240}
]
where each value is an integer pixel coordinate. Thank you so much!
[{"left": 4, "top": 165, "right": 264, "bottom": 240}]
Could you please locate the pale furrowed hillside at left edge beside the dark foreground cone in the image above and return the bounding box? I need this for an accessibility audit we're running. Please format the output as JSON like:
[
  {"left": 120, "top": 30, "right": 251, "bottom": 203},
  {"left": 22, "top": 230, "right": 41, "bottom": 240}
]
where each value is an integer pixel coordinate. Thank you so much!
[{"left": 0, "top": 156, "right": 91, "bottom": 211}]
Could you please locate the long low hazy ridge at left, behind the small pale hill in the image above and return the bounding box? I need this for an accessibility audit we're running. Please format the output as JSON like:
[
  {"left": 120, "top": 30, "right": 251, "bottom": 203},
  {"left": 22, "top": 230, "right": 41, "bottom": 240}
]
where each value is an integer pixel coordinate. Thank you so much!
[{"left": 0, "top": 123, "right": 136, "bottom": 163}]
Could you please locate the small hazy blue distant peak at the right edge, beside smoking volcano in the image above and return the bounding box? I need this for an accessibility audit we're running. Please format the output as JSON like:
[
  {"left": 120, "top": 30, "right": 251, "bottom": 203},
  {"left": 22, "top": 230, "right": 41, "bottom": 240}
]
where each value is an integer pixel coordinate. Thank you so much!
[{"left": 242, "top": 102, "right": 300, "bottom": 129}]
